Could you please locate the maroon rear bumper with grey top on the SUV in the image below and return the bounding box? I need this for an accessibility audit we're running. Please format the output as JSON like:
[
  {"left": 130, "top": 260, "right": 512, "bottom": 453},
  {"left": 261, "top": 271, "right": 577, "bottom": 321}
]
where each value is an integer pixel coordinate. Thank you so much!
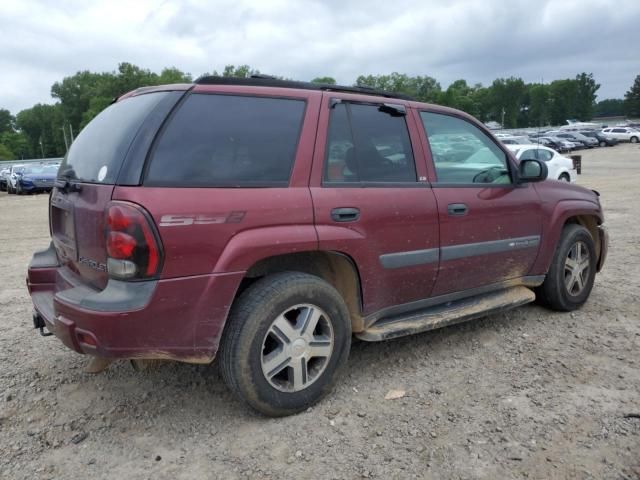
[{"left": 27, "top": 247, "right": 243, "bottom": 363}]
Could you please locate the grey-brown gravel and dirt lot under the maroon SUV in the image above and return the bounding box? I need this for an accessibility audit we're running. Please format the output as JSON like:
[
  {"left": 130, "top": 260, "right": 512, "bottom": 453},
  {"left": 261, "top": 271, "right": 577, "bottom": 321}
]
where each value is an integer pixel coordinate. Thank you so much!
[{"left": 0, "top": 145, "right": 640, "bottom": 480}]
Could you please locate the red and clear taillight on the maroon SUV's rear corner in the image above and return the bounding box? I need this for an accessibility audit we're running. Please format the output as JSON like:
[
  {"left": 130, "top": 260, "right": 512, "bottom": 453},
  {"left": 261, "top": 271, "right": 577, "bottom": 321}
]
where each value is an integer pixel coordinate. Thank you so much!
[{"left": 105, "top": 202, "right": 162, "bottom": 280}]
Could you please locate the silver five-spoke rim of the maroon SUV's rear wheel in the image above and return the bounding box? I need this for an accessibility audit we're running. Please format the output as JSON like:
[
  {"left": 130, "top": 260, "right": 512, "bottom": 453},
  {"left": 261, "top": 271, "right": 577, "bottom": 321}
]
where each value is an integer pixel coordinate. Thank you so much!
[{"left": 261, "top": 304, "right": 334, "bottom": 392}]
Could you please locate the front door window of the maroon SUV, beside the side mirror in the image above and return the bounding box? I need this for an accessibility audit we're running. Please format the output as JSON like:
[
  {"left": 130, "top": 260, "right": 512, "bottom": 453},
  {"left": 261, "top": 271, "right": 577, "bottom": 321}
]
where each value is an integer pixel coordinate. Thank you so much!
[{"left": 420, "top": 112, "right": 511, "bottom": 184}]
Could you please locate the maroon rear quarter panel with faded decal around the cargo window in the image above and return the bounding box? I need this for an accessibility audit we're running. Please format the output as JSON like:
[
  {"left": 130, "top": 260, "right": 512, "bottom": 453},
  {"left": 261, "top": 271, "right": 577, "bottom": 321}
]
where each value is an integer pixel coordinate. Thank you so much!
[{"left": 113, "top": 85, "right": 321, "bottom": 278}]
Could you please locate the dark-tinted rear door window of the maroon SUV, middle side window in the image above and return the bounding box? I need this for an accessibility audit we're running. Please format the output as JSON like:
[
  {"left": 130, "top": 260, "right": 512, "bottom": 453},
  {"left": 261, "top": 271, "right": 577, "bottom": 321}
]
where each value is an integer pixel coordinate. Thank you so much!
[{"left": 324, "top": 103, "right": 416, "bottom": 182}]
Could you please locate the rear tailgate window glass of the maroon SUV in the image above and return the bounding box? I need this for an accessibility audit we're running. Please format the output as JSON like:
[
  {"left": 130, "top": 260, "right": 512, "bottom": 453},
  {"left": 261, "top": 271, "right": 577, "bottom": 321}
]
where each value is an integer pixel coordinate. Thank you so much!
[{"left": 58, "top": 92, "right": 167, "bottom": 184}]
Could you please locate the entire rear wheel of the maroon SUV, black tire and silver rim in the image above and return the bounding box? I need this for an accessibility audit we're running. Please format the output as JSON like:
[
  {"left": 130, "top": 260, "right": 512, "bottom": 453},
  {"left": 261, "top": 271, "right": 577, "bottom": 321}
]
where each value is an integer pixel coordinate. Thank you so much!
[{"left": 219, "top": 272, "right": 351, "bottom": 417}]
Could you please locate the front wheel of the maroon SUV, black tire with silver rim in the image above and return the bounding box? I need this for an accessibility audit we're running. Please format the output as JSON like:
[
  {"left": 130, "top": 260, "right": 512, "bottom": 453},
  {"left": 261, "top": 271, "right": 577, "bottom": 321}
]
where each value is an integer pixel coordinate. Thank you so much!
[{"left": 536, "top": 224, "right": 597, "bottom": 312}]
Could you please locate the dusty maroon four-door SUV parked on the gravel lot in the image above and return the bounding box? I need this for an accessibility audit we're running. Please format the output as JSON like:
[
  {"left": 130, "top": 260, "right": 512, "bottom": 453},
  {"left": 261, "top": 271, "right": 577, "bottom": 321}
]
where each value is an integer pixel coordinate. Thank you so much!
[{"left": 27, "top": 77, "right": 607, "bottom": 415}]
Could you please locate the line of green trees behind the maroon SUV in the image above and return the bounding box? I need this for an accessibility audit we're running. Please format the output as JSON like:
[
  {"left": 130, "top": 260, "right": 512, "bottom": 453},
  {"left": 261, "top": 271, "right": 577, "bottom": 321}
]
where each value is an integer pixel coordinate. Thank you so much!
[{"left": 0, "top": 63, "right": 640, "bottom": 159}]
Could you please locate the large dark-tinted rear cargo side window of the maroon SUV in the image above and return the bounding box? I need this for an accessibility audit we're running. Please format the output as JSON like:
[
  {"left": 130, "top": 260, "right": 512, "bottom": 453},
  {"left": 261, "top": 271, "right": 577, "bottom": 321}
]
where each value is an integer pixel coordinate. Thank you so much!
[{"left": 144, "top": 94, "right": 305, "bottom": 187}]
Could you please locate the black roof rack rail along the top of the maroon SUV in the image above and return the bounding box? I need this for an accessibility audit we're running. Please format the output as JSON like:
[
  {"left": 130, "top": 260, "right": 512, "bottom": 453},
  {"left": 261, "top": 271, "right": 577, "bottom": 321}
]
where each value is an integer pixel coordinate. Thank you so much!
[{"left": 194, "top": 74, "right": 415, "bottom": 100}]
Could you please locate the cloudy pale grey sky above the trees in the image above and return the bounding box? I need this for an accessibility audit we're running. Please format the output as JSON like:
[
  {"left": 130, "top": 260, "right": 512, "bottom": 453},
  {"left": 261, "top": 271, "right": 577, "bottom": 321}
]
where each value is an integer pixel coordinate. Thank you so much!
[{"left": 0, "top": 0, "right": 640, "bottom": 114}]
